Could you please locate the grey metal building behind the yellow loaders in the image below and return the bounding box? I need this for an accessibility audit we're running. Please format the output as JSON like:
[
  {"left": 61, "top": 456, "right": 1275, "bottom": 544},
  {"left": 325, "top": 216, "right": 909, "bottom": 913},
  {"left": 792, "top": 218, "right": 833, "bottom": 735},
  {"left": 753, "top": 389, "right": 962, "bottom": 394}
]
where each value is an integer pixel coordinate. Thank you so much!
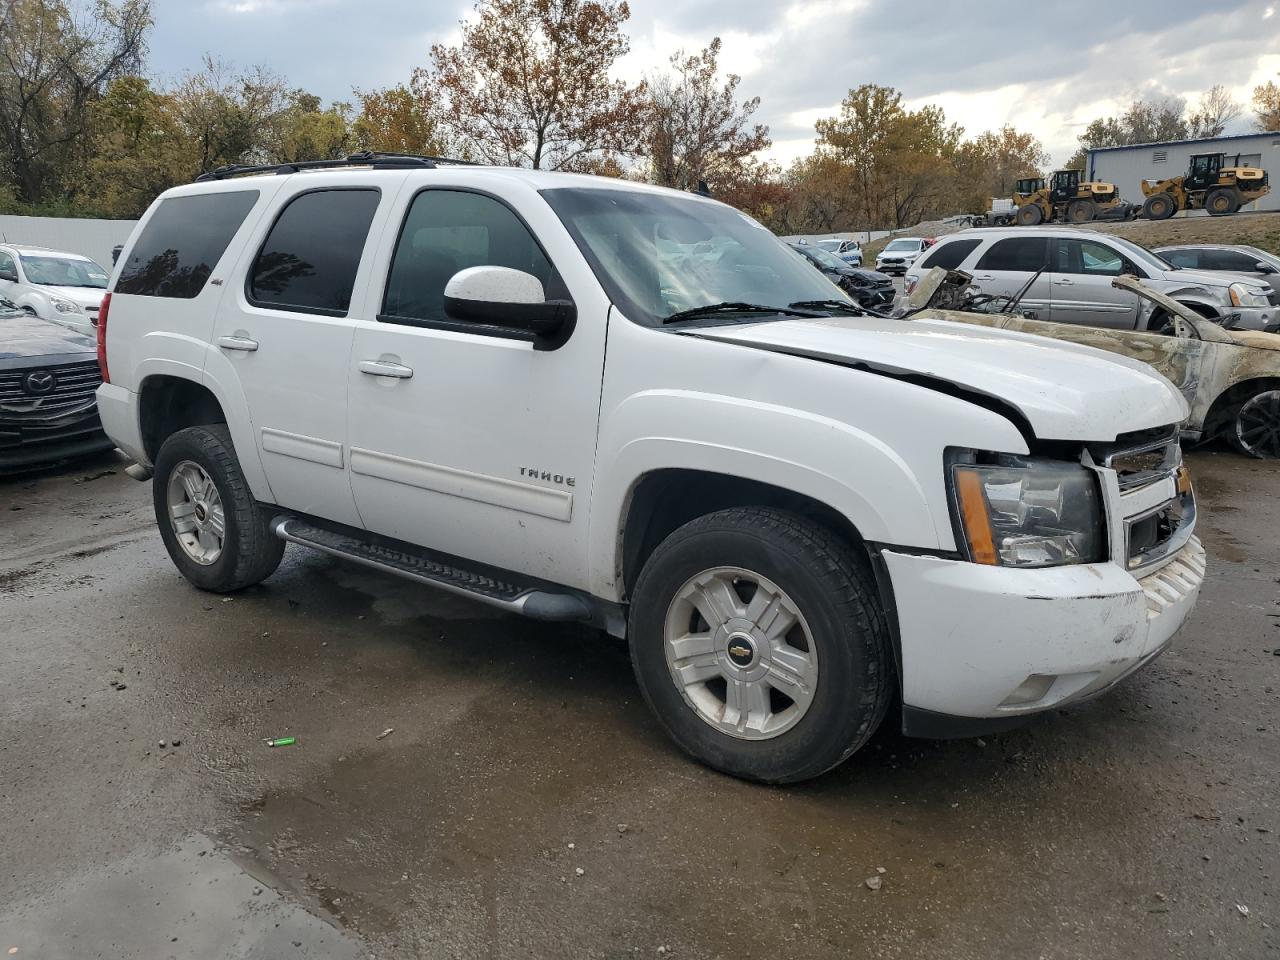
[{"left": 1085, "top": 132, "right": 1280, "bottom": 211}]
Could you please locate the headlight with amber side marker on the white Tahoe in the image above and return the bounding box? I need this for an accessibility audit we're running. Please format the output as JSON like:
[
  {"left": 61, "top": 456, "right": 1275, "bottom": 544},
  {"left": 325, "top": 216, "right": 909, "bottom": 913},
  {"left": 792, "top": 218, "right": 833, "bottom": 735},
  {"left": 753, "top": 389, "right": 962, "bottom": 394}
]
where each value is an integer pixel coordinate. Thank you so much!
[{"left": 951, "top": 456, "right": 1106, "bottom": 567}]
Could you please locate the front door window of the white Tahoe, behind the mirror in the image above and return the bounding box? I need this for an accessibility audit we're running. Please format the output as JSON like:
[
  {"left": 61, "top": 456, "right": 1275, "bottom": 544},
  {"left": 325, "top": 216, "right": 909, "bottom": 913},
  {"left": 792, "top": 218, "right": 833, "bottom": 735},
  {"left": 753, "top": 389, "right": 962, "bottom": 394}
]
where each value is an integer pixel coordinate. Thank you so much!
[{"left": 378, "top": 189, "right": 558, "bottom": 323}]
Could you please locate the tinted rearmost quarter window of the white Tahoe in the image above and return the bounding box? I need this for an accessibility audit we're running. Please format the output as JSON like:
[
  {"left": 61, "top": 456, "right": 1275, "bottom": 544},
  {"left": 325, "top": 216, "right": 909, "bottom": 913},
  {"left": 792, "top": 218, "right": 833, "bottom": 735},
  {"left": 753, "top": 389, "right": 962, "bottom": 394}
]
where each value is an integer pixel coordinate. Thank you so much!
[{"left": 115, "top": 189, "right": 257, "bottom": 300}]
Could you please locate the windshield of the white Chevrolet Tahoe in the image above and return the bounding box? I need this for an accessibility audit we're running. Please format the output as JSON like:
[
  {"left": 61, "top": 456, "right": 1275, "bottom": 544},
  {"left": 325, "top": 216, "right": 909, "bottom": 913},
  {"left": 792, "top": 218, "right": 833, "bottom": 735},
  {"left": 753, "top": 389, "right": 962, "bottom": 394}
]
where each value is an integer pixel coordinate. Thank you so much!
[{"left": 543, "top": 187, "right": 851, "bottom": 325}]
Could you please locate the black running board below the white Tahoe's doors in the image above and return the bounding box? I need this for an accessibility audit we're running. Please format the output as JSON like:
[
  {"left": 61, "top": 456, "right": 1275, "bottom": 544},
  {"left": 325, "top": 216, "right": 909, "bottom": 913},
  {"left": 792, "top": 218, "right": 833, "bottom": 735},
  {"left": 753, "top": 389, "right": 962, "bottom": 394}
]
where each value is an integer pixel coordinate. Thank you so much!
[{"left": 271, "top": 517, "right": 598, "bottom": 623}]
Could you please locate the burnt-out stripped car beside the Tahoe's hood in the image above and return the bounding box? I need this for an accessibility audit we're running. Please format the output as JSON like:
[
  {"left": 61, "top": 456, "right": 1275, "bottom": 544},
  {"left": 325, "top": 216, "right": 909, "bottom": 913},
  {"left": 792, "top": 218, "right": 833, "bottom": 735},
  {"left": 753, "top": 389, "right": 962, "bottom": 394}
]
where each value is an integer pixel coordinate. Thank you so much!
[{"left": 902, "top": 269, "right": 1280, "bottom": 458}]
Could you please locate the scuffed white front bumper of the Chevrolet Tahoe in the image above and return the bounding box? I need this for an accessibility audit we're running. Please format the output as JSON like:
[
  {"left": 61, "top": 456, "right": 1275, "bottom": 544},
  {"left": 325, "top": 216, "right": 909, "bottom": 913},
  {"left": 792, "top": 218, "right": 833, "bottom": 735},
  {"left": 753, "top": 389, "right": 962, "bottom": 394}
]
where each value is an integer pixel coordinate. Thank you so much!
[{"left": 882, "top": 538, "right": 1204, "bottom": 732}]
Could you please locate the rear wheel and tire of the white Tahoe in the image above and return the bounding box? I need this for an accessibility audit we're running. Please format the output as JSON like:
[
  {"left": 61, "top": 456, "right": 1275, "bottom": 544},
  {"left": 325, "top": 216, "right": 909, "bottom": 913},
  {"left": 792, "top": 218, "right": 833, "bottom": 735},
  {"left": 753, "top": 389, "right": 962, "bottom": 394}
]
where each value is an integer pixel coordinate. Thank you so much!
[{"left": 151, "top": 424, "right": 284, "bottom": 593}]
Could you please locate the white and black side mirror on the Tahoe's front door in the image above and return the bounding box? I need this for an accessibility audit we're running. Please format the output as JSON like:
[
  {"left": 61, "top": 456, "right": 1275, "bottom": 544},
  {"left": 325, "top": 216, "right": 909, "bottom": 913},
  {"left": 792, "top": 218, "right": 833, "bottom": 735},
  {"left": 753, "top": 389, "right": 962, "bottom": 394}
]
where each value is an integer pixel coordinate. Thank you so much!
[{"left": 444, "top": 266, "right": 577, "bottom": 348}]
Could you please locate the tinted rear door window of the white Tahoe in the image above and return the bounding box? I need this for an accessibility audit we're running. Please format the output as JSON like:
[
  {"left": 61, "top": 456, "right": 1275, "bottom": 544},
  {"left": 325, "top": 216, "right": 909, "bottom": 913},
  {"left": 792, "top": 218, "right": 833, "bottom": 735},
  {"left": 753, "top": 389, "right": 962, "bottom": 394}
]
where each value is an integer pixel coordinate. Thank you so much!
[{"left": 248, "top": 189, "right": 381, "bottom": 316}]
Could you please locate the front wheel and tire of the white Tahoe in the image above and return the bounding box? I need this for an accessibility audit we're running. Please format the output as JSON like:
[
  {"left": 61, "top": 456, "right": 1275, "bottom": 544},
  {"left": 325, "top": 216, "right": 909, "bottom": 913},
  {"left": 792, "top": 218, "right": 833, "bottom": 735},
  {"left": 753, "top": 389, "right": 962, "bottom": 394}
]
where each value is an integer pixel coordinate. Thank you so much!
[{"left": 628, "top": 507, "right": 895, "bottom": 783}]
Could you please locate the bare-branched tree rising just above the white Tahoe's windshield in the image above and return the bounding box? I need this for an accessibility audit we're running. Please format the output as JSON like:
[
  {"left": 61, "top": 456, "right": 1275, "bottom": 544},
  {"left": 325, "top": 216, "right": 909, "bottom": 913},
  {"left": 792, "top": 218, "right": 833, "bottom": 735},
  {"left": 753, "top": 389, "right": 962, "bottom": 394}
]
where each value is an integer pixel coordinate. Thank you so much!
[{"left": 645, "top": 37, "right": 772, "bottom": 191}]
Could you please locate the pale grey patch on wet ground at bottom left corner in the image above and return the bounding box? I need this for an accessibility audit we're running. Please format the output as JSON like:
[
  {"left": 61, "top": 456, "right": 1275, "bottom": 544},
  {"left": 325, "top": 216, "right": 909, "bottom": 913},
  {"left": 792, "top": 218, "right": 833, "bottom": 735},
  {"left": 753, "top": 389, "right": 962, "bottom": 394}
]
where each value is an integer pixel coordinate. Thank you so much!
[{"left": 0, "top": 835, "right": 366, "bottom": 960}]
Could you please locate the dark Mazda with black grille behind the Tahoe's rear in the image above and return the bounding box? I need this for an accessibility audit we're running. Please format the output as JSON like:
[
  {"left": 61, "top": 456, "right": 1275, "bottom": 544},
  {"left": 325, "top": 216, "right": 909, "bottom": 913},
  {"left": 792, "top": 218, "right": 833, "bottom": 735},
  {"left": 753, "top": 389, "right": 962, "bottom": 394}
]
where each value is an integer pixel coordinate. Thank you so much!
[{"left": 0, "top": 301, "right": 114, "bottom": 474}]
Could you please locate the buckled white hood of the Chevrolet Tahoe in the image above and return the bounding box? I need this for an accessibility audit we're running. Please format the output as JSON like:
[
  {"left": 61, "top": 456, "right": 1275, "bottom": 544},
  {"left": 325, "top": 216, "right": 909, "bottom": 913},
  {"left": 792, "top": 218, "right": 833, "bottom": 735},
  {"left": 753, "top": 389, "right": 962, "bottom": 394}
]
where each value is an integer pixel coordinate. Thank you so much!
[{"left": 694, "top": 317, "right": 1188, "bottom": 442}]
